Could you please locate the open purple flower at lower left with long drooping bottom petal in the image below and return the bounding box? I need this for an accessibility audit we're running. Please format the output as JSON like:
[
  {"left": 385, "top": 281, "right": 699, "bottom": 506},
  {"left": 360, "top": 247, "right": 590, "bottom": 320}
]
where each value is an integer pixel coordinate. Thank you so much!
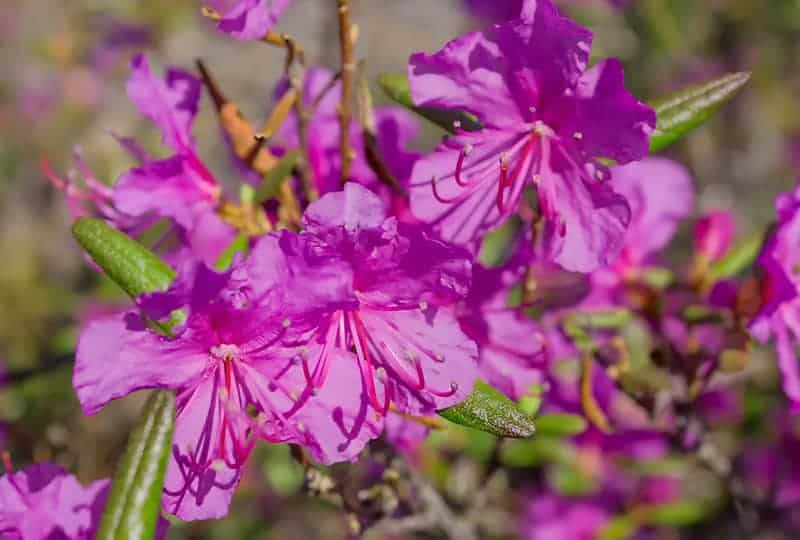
[{"left": 73, "top": 264, "right": 375, "bottom": 520}]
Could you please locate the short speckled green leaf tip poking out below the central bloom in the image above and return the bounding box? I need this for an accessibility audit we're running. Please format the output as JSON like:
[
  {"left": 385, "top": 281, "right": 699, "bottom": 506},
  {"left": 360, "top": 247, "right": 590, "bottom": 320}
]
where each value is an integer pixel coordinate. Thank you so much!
[{"left": 439, "top": 381, "right": 535, "bottom": 438}]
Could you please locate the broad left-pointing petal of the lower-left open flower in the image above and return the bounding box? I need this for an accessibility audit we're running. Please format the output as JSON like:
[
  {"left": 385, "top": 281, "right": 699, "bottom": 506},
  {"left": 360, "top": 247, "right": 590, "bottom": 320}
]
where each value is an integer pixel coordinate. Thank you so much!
[{"left": 72, "top": 313, "right": 208, "bottom": 414}]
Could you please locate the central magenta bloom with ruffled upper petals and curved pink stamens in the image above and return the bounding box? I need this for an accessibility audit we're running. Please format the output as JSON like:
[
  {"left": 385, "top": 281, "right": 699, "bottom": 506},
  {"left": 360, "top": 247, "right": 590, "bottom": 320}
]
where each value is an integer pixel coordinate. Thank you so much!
[{"left": 247, "top": 182, "right": 477, "bottom": 422}]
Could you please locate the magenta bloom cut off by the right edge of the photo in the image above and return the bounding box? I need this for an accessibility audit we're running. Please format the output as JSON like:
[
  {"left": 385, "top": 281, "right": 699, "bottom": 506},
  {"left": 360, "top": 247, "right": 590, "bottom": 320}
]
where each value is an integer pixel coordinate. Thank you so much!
[{"left": 750, "top": 184, "right": 800, "bottom": 412}]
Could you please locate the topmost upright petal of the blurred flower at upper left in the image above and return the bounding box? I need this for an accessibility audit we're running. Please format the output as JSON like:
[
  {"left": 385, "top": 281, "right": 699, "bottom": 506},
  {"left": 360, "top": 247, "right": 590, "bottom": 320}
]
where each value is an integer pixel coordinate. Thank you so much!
[{"left": 126, "top": 54, "right": 202, "bottom": 152}]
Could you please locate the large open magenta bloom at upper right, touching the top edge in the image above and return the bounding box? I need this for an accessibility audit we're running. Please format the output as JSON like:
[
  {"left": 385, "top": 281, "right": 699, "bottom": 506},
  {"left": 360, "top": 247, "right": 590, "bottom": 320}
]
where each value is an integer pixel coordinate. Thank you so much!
[{"left": 409, "top": 0, "right": 655, "bottom": 272}]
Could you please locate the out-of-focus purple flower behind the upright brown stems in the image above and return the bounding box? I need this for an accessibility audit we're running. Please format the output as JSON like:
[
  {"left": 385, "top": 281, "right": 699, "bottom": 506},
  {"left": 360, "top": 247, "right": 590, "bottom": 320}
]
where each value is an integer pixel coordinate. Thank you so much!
[{"left": 274, "top": 67, "right": 419, "bottom": 205}]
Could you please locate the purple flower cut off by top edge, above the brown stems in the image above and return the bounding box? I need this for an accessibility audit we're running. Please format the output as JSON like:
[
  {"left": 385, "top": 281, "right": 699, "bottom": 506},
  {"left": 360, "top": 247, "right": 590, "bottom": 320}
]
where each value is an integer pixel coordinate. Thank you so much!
[{"left": 207, "top": 0, "right": 292, "bottom": 40}]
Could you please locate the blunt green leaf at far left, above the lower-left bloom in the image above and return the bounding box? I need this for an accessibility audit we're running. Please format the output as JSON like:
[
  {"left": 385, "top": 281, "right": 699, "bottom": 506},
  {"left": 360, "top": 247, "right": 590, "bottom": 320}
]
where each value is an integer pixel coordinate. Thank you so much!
[{"left": 72, "top": 217, "right": 175, "bottom": 298}]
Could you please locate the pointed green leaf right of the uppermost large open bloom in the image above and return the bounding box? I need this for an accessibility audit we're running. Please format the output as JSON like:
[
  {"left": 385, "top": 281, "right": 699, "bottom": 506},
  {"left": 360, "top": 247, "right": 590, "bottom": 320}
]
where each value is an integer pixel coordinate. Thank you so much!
[{"left": 650, "top": 72, "right": 750, "bottom": 152}]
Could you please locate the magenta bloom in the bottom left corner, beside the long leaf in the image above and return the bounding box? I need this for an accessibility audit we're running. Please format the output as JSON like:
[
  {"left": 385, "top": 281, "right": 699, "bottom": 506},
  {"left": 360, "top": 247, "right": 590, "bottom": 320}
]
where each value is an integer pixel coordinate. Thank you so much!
[{"left": 0, "top": 462, "right": 110, "bottom": 540}]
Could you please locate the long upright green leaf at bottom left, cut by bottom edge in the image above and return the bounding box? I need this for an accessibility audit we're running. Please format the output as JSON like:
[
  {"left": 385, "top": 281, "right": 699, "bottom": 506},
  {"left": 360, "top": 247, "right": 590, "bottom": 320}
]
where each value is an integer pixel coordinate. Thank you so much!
[{"left": 97, "top": 391, "right": 175, "bottom": 540}]
